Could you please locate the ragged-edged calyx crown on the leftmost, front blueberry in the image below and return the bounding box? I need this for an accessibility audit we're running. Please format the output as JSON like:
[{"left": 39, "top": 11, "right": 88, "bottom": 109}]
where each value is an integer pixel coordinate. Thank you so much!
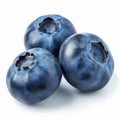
[{"left": 15, "top": 52, "right": 35, "bottom": 71}]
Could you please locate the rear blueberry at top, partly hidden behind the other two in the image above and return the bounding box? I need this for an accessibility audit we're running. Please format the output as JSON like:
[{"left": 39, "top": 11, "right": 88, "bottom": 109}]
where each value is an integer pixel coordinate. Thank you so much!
[{"left": 24, "top": 14, "right": 76, "bottom": 58}]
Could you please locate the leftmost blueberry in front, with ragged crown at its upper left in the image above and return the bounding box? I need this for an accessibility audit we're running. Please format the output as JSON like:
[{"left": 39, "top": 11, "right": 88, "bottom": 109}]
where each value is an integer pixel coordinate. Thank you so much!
[{"left": 6, "top": 48, "right": 62, "bottom": 104}]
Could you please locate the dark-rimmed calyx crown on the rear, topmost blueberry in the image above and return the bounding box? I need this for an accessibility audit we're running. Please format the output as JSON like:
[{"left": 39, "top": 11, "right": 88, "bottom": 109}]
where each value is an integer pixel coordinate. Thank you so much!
[{"left": 38, "top": 17, "right": 58, "bottom": 34}]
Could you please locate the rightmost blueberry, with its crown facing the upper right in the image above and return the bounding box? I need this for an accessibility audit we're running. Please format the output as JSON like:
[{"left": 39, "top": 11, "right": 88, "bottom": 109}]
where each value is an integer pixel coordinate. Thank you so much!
[{"left": 60, "top": 33, "right": 114, "bottom": 92}]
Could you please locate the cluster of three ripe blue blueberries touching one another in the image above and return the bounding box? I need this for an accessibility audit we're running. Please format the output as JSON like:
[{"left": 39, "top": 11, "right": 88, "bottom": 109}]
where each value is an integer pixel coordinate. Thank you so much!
[{"left": 6, "top": 15, "right": 114, "bottom": 104}]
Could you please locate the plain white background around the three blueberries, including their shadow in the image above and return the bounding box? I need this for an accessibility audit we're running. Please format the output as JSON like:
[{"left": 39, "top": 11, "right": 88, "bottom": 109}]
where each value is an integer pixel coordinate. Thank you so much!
[{"left": 0, "top": 0, "right": 120, "bottom": 120}]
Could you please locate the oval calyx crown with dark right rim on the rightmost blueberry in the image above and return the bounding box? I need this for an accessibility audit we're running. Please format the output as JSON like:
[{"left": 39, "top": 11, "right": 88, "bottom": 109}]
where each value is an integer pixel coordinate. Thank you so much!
[{"left": 91, "top": 42, "right": 108, "bottom": 63}]
